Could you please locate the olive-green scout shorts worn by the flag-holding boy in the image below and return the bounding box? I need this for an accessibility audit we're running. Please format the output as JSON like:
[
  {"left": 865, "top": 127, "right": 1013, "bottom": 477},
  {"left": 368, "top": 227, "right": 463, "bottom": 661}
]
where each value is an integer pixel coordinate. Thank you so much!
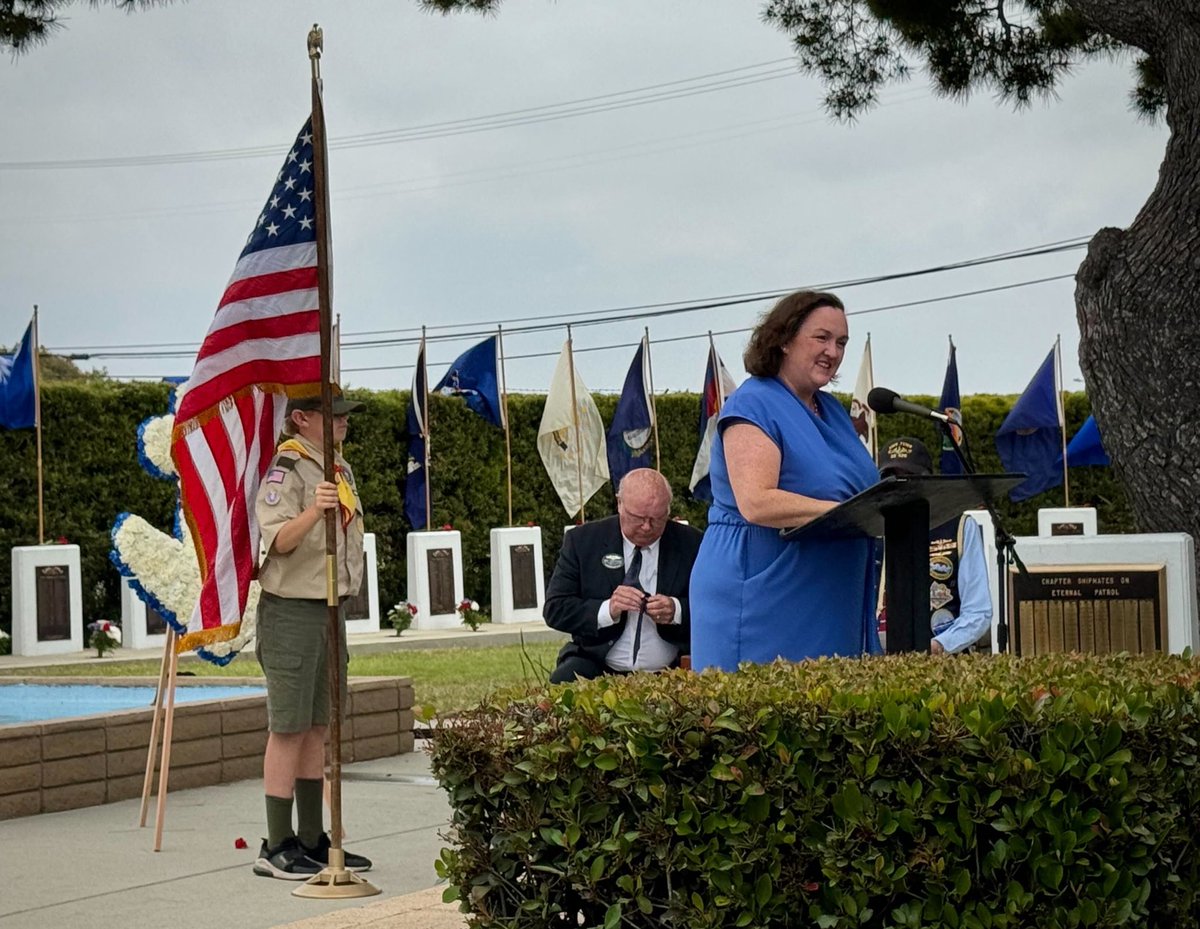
[{"left": 254, "top": 591, "right": 348, "bottom": 732}]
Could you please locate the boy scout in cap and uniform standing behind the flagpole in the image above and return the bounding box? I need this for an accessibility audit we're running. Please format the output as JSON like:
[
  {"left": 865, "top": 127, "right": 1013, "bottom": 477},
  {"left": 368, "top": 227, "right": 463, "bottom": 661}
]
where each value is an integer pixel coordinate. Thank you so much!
[{"left": 254, "top": 397, "right": 371, "bottom": 881}]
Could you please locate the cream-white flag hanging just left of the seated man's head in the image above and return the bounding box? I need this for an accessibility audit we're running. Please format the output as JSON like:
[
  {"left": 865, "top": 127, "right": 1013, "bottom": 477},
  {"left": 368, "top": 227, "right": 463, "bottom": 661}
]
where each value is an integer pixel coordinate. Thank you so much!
[{"left": 538, "top": 340, "right": 608, "bottom": 516}]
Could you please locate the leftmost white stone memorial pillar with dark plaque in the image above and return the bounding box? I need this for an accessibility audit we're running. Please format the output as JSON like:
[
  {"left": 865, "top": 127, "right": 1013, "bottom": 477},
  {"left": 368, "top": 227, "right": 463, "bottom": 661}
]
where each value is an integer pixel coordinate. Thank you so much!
[{"left": 12, "top": 545, "right": 84, "bottom": 655}]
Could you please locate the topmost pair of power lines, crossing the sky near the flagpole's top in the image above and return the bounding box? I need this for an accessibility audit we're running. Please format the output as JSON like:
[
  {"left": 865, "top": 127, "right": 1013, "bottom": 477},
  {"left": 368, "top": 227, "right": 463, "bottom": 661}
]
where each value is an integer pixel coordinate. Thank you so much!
[{"left": 0, "top": 59, "right": 799, "bottom": 170}]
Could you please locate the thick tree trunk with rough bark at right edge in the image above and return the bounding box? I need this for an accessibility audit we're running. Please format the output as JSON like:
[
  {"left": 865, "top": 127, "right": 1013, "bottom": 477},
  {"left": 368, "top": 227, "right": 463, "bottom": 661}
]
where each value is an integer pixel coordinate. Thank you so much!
[{"left": 1072, "top": 0, "right": 1200, "bottom": 607}]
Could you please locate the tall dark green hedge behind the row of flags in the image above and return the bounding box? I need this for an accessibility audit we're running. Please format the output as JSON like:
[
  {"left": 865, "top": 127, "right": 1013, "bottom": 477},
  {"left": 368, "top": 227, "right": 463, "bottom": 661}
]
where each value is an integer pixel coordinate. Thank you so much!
[{"left": 0, "top": 379, "right": 1135, "bottom": 631}]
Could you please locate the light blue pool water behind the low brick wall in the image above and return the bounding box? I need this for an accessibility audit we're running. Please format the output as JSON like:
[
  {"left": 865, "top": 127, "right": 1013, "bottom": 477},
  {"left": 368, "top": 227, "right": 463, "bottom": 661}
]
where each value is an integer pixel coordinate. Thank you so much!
[{"left": 0, "top": 684, "right": 266, "bottom": 726}]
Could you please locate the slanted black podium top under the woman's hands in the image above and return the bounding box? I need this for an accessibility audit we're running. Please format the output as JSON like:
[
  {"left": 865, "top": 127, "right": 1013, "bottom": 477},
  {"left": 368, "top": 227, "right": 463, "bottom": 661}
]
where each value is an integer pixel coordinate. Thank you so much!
[{"left": 780, "top": 474, "right": 1025, "bottom": 539}]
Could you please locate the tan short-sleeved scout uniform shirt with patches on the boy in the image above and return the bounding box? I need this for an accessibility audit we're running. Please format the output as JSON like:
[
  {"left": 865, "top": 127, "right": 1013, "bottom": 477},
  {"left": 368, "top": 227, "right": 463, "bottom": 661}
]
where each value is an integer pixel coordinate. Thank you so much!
[{"left": 254, "top": 436, "right": 364, "bottom": 600}]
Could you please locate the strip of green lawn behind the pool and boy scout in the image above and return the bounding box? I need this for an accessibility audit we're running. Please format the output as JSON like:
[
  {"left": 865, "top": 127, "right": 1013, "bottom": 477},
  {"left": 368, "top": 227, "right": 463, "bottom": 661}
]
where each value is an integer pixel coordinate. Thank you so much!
[{"left": 0, "top": 642, "right": 559, "bottom": 715}]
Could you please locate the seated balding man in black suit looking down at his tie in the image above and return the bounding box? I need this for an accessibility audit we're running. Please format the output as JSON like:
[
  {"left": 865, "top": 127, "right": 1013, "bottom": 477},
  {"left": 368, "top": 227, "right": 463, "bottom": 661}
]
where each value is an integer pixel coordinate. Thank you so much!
[{"left": 542, "top": 468, "right": 701, "bottom": 684}]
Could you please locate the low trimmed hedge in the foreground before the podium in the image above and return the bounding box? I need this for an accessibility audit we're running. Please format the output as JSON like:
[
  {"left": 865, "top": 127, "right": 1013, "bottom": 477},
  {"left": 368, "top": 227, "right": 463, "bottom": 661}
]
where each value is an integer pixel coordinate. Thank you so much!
[{"left": 433, "top": 655, "right": 1200, "bottom": 929}]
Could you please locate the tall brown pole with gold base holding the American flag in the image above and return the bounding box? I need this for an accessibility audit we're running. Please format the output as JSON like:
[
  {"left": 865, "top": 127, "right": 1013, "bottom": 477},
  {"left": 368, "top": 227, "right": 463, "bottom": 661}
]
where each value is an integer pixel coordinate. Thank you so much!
[{"left": 292, "top": 23, "right": 379, "bottom": 898}]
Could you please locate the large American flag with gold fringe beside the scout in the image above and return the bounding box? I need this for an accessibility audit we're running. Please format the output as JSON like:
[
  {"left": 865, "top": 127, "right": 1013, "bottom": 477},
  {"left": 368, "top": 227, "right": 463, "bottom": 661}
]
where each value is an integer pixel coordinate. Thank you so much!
[{"left": 172, "top": 119, "right": 320, "bottom": 660}]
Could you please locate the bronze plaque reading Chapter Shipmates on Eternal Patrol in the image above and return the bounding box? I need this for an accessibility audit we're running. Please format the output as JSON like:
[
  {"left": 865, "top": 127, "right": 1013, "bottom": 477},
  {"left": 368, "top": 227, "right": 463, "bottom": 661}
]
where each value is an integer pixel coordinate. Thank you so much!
[{"left": 1008, "top": 564, "right": 1166, "bottom": 655}]
